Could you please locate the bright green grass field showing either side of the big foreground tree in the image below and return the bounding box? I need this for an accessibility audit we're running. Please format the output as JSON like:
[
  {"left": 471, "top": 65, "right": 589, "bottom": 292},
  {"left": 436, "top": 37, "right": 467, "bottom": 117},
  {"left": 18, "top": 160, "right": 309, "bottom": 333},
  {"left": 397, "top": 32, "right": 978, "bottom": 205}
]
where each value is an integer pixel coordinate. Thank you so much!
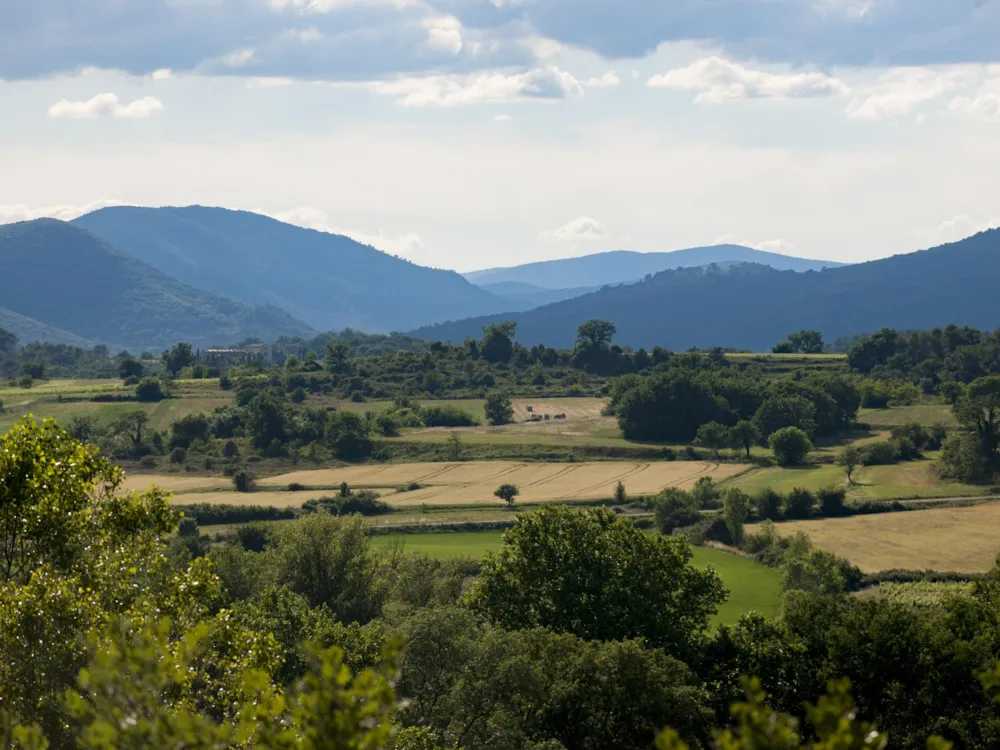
[{"left": 372, "top": 531, "right": 781, "bottom": 625}]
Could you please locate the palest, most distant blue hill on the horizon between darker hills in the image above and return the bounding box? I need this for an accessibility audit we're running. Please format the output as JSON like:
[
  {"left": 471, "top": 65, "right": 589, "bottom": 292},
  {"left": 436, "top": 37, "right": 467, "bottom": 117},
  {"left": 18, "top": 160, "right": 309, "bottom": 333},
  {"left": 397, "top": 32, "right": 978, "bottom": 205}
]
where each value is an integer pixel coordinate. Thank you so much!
[{"left": 465, "top": 245, "right": 843, "bottom": 289}]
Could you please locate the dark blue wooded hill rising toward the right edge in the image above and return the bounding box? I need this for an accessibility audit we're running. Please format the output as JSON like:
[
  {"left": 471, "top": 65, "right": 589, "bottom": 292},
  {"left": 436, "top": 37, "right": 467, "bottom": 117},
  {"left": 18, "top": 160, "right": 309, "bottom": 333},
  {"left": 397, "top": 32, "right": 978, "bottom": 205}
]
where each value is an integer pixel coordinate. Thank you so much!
[{"left": 414, "top": 229, "right": 1000, "bottom": 351}]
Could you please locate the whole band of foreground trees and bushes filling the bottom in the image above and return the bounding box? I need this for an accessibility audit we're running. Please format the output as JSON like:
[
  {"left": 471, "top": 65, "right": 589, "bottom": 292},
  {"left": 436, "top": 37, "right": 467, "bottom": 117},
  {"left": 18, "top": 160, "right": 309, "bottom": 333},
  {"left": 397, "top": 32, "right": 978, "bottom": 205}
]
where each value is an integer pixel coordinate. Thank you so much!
[{"left": 0, "top": 421, "right": 1000, "bottom": 750}]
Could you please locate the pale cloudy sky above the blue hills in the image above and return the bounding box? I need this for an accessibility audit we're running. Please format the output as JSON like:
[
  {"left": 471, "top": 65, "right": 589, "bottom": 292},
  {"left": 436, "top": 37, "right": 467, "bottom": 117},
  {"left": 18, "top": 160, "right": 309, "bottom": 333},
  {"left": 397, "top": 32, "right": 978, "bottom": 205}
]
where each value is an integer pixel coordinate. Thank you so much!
[{"left": 0, "top": 0, "right": 1000, "bottom": 271}]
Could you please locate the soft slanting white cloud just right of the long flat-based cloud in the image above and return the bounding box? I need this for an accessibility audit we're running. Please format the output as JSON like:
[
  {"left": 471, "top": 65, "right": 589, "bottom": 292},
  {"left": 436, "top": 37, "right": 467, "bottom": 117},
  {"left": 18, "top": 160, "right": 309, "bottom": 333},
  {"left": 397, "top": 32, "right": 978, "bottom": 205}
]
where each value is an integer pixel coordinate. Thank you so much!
[{"left": 847, "top": 67, "right": 975, "bottom": 120}]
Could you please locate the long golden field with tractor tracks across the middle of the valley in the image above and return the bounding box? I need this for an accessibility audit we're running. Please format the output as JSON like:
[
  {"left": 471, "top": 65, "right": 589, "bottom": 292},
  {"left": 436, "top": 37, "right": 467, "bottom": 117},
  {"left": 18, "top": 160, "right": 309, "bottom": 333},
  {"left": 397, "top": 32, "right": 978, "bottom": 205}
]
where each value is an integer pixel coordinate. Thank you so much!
[{"left": 128, "top": 461, "right": 745, "bottom": 507}]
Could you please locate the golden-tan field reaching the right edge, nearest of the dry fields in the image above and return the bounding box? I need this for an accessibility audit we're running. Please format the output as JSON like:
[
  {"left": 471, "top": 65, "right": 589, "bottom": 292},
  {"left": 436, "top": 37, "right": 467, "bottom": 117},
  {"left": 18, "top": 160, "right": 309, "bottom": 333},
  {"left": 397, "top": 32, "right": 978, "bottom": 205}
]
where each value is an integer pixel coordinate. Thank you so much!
[{"left": 747, "top": 503, "right": 1000, "bottom": 573}]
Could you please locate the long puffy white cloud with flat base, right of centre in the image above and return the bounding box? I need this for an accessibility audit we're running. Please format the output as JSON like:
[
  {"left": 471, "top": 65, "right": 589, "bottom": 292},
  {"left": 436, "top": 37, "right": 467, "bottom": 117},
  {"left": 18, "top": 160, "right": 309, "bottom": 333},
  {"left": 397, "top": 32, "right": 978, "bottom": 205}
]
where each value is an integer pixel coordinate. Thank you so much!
[{"left": 647, "top": 56, "right": 848, "bottom": 104}]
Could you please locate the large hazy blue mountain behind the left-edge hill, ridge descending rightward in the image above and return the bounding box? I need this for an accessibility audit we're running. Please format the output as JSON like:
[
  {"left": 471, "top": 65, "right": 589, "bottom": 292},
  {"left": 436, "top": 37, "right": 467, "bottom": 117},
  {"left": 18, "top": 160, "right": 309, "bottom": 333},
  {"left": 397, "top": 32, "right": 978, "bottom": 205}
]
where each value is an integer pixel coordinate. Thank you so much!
[{"left": 74, "top": 206, "right": 506, "bottom": 333}]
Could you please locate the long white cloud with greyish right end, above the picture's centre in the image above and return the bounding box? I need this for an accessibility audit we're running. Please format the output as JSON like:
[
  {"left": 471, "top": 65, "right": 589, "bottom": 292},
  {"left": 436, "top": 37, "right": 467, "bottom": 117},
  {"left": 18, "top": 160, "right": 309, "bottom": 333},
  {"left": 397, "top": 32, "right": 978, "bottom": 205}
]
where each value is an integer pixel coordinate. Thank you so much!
[{"left": 373, "top": 67, "right": 583, "bottom": 107}]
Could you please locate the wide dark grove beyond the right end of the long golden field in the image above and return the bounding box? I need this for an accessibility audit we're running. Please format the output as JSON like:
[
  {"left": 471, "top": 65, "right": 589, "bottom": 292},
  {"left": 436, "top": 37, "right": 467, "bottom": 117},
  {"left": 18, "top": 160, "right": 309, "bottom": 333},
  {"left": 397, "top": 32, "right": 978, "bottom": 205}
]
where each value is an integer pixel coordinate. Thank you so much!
[{"left": 609, "top": 362, "right": 860, "bottom": 450}]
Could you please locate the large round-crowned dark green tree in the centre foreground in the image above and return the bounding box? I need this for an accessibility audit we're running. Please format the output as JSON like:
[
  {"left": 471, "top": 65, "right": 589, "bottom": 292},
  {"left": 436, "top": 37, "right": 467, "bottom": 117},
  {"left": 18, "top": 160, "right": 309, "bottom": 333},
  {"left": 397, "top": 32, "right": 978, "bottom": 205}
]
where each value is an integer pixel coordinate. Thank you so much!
[{"left": 469, "top": 507, "right": 726, "bottom": 659}]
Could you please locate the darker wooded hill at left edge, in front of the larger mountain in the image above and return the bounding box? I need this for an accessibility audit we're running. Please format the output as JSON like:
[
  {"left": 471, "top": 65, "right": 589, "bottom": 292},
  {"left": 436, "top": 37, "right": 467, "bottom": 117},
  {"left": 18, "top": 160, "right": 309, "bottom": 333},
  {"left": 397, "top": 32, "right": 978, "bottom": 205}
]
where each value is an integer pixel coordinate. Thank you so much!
[{"left": 0, "top": 219, "right": 311, "bottom": 349}]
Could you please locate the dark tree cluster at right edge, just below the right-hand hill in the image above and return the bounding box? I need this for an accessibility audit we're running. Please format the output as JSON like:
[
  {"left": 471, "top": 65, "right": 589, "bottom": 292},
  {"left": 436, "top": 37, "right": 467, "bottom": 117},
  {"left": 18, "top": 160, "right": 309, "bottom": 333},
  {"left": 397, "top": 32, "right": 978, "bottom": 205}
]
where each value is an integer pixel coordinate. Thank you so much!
[{"left": 847, "top": 325, "right": 1000, "bottom": 393}]
